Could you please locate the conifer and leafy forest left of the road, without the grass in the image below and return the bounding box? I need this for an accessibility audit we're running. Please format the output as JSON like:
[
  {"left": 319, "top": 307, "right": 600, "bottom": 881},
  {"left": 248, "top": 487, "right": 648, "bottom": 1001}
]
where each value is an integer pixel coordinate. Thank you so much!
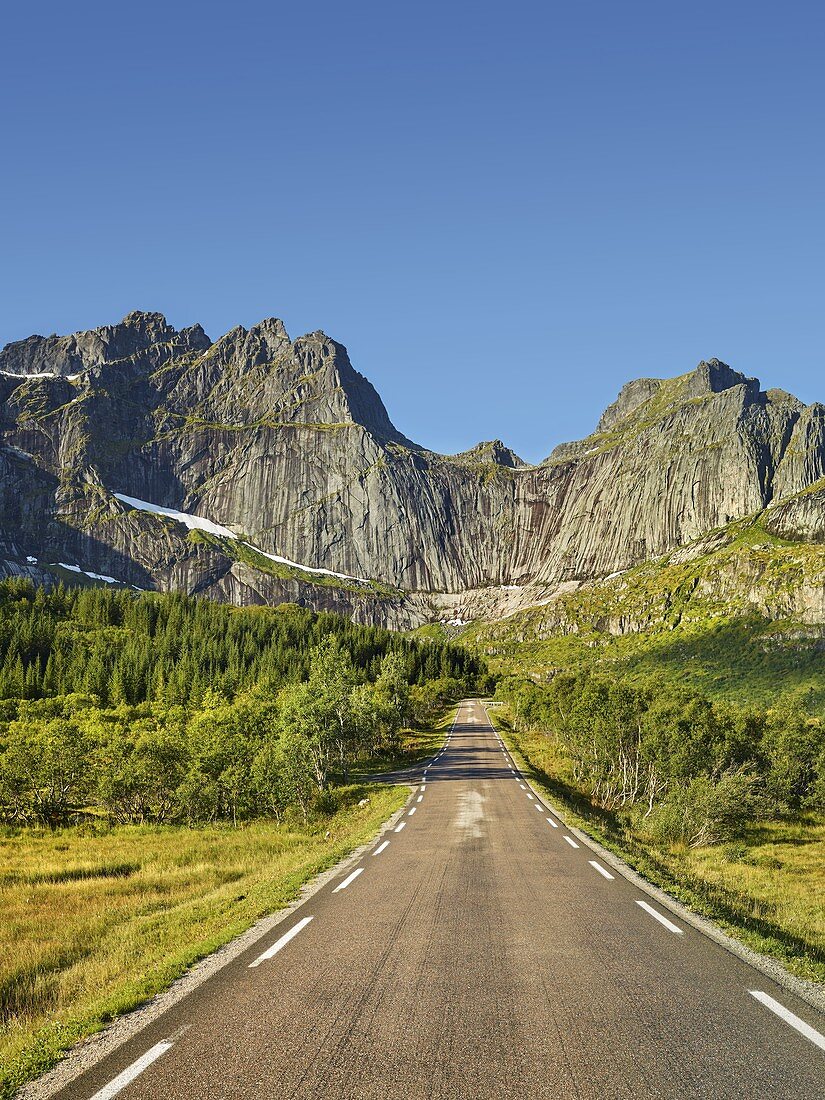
[{"left": 0, "top": 580, "right": 493, "bottom": 826}]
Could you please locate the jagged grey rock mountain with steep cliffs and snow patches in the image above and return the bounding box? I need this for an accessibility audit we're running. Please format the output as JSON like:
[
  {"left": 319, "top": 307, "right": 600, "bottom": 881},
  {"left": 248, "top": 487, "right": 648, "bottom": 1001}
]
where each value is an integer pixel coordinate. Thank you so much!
[{"left": 0, "top": 312, "right": 825, "bottom": 627}]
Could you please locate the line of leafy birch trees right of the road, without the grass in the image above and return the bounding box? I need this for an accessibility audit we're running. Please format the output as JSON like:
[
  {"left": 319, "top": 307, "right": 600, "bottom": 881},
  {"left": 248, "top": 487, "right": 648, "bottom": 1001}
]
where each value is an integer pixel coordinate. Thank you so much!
[{"left": 498, "top": 673, "right": 825, "bottom": 847}]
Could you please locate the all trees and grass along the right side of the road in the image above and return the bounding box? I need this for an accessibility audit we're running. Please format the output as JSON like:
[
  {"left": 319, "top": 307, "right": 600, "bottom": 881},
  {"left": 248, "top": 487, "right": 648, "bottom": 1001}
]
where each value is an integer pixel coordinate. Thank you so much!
[{"left": 491, "top": 673, "right": 825, "bottom": 982}]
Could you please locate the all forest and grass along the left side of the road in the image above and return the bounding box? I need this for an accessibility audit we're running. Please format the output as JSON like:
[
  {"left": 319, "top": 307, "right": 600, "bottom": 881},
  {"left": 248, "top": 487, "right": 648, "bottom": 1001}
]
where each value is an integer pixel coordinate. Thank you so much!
[{"left": 0, "top": 581, "right": 488, "bottom": 1098}]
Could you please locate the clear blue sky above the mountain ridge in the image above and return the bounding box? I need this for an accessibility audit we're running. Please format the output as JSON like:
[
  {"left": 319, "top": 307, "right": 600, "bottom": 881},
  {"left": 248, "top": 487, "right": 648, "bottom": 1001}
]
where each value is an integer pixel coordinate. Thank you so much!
[{"left": 0, "top": 0, "right": 825, "bottom": 461}]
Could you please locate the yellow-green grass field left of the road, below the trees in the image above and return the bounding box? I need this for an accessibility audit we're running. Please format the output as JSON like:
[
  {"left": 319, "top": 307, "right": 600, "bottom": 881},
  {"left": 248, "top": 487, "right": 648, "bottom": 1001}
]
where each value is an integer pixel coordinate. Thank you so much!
[{"left": 0, "top": 784, "right": 408, "bottom": 1098}]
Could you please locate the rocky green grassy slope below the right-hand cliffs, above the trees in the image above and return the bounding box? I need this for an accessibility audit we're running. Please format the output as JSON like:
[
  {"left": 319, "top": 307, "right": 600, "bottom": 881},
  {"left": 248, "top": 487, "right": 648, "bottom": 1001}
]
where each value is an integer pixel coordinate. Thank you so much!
[{"left": 460, "top": 517, "right": 825, "bottom": 715}]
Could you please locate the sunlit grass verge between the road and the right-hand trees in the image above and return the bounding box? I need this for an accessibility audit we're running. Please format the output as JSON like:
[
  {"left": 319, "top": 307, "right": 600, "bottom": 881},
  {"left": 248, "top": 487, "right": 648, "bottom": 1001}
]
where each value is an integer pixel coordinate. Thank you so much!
[{"left": 490, "top": 708, "right": 825, "bottom": 982}]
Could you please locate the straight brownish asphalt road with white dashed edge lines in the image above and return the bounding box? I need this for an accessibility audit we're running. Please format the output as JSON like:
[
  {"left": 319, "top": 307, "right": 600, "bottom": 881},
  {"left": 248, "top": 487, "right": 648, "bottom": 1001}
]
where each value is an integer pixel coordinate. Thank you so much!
[{"left": 59, "top": 701, "right": 825, "bottom": 1100}]
